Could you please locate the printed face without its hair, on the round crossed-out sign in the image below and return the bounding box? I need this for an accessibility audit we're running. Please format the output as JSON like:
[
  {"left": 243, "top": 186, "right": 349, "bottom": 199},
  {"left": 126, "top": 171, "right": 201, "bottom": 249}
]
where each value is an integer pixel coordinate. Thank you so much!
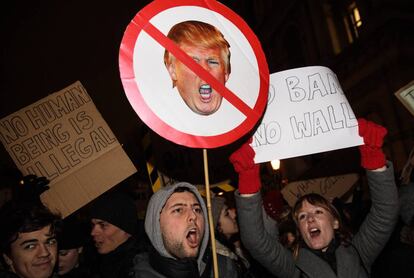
[{"left": 168, "top": 43, "right": 229, "bottom": 115}]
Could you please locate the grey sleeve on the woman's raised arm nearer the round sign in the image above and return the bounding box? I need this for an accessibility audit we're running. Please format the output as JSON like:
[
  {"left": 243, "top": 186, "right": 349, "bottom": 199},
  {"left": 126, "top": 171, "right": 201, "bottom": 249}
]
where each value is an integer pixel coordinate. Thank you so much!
[{"left": 235, "top": 190, "right": 299, "bottom": 278}]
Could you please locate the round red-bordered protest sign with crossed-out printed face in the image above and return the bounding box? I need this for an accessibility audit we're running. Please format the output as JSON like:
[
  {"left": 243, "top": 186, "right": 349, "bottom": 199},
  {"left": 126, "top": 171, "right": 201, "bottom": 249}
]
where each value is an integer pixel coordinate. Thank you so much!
[{"left": 119, "top": 0, "right": 269, "bottom": 148}]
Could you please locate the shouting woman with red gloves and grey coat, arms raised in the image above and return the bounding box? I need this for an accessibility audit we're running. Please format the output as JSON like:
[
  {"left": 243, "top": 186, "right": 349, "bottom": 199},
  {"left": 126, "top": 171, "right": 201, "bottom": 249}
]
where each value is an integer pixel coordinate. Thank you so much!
[{"left": 230, "top": 119, "right": 398, "bottom": 278}]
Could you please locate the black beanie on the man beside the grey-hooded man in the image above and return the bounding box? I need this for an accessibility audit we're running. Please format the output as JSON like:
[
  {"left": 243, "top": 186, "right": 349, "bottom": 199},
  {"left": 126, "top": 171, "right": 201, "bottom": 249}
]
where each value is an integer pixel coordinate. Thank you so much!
[{"left": 90, "top": 193, "right": 138, "bottom": 236}]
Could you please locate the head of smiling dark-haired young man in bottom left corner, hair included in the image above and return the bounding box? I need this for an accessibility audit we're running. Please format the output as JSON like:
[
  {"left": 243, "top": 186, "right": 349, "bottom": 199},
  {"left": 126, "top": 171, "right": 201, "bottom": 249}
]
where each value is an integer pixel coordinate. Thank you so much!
[{"left": 0, "top": 202, "right": 60, "bottom": 278}]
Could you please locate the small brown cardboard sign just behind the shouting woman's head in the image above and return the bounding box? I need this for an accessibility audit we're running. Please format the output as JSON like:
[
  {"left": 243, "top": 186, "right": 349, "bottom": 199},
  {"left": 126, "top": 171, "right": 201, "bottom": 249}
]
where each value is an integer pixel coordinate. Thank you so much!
[{"left": 281, "top": 174, "right": 359, "bottom": 207}]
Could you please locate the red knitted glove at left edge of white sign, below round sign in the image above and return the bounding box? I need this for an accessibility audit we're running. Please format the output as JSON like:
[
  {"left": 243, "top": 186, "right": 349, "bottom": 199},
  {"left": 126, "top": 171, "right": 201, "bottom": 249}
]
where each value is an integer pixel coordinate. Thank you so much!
[{"left": 230, "top": 138, "right": 261, "bottom": 194}]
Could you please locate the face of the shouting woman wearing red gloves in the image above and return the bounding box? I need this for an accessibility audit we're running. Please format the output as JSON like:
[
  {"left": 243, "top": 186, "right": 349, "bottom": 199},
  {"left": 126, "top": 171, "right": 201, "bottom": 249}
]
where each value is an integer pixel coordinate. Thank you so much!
[{"left": 296, "top": 200, "right": 339, "bottom": 251}]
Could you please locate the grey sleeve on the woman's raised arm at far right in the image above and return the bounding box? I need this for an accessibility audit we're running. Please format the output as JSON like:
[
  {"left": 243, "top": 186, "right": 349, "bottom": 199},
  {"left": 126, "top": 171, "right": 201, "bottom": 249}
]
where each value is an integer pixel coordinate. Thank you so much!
[{"left": 352, "top": 162, "right": 399, "bottom": 269}]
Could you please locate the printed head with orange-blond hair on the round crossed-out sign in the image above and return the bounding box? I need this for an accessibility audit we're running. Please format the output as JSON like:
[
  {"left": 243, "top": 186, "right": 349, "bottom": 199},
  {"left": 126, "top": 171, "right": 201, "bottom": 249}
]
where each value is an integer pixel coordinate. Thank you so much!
[{"left": 164, "top": 21, "right": 230, "bottom": 115}]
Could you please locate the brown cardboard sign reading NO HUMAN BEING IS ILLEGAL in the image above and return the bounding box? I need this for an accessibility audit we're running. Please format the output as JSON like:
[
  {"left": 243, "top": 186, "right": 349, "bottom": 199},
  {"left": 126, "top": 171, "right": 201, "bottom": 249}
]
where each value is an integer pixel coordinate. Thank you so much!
[{"left": 0, "top": 81, "right": 136, "bottom": 216}]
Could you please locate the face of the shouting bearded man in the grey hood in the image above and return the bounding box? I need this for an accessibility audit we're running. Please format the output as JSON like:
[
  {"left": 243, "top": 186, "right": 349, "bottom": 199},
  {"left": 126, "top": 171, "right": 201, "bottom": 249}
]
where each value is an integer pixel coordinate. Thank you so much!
[{"left": 160, "top": 191, "right": 204, "bottom": 258}]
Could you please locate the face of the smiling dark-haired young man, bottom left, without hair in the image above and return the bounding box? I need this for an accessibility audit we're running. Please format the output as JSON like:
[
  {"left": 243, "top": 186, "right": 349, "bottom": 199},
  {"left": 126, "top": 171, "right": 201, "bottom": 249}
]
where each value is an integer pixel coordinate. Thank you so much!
[{"left": 3, "top": 225, "right": 57, "bottom": 278}]
